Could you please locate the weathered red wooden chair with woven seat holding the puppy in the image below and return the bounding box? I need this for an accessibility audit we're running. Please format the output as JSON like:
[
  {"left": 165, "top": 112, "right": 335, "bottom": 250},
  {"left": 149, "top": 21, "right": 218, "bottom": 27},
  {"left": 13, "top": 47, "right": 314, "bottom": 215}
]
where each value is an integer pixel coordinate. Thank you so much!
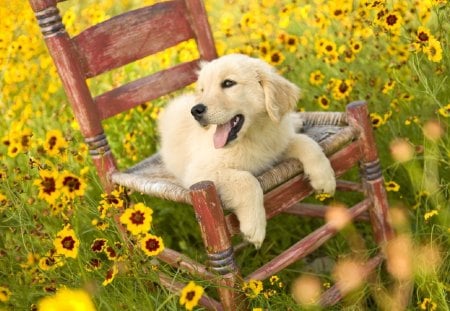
[{"left": 29, "top": 0, "right": 393, "bottom": 310}]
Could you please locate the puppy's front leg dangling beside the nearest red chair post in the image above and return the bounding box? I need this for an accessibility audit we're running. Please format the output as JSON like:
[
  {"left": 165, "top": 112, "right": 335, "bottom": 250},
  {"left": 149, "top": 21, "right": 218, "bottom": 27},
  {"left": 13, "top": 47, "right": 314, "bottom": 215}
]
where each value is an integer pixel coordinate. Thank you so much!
[{"left": 214, "top": 169, "right": 266, "bottom": 248}]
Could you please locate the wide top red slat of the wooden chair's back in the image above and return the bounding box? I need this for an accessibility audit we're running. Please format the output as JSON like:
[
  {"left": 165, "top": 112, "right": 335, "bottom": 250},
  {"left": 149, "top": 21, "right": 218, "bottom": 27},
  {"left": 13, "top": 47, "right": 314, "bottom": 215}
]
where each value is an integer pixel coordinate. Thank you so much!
[{"left": 74, "top": 1, "right": 194, "bottom": 78}]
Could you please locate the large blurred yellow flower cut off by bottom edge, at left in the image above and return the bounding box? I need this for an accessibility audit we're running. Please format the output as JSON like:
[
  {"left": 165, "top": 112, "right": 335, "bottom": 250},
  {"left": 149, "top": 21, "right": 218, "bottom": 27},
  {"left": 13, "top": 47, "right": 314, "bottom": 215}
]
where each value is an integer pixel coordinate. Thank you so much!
[{"left": 37, "top": 288, "right": 95, "bottom": 311}]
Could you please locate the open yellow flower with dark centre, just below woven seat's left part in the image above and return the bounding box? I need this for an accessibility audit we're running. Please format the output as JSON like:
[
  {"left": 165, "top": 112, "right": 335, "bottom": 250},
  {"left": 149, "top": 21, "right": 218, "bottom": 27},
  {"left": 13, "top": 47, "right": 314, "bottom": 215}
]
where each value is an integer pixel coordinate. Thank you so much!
[{"left": 120, "top": 203, "right": 153, "bottom": 235}]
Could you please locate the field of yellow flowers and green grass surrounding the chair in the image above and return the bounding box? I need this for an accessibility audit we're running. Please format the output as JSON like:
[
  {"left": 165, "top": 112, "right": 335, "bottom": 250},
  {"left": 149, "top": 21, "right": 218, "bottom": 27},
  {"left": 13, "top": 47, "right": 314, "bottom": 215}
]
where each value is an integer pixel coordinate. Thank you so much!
[{"left": 0, "top": 0, "right": 450, "bottom": 310}]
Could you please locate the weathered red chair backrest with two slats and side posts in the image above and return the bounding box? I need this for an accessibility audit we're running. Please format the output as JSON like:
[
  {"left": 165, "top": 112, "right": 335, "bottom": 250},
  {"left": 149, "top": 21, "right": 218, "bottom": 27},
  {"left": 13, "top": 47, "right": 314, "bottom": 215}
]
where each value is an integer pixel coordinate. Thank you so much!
[{"left": 29, "top": 0, "right": 217, "bottom": 189}]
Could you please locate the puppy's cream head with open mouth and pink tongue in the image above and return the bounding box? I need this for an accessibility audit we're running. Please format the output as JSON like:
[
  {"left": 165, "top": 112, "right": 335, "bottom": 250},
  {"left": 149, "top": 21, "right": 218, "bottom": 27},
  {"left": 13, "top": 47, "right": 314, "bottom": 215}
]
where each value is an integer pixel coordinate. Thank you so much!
[{"left": 191, "top": 54, "right": 300, "bottom": 148}]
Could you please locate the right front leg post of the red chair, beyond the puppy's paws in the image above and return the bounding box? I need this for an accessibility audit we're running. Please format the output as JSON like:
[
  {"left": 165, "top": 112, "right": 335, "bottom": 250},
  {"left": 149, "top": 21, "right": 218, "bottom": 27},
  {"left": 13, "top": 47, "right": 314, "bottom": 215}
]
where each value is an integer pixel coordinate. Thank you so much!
[{"left": 347, "top": 102, "right": 394, "bottom": 245}]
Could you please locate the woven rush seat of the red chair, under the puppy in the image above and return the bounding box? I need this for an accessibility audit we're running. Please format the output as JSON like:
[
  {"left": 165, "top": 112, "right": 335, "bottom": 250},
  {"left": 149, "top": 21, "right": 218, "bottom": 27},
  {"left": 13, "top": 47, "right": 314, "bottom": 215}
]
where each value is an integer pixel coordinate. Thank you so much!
[{"left": 111, "top": 112, "right": 356, "bottom": 204}]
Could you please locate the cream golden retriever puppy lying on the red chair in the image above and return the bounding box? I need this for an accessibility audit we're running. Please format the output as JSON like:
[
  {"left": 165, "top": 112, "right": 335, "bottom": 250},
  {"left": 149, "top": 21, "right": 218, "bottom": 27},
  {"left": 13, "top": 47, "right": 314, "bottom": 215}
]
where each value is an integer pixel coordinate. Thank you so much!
[{"left": 159, "top": 54, "right": 336, "bottom": 248}]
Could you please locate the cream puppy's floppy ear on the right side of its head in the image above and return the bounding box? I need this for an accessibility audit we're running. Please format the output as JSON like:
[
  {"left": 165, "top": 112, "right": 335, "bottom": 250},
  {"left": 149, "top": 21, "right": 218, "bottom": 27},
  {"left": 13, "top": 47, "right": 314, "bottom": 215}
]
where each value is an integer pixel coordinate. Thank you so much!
[{"left": 257, "top": 63, "right": 300, "bottom": 122}]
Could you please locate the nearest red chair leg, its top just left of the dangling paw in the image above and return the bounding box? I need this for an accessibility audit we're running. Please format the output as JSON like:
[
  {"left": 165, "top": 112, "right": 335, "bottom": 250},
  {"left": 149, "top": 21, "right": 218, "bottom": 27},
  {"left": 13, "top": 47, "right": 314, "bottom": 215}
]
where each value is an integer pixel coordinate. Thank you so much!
[{"left": 191, "top": 181, "right": 240, "bottom": 310}]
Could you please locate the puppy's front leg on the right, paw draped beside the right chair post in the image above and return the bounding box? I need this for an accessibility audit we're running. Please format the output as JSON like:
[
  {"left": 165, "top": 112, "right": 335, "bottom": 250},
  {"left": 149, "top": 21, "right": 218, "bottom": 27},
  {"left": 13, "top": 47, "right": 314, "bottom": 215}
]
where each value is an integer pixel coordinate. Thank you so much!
[{"left": 286, "top": 134, "right": 336, "bottom": 195}]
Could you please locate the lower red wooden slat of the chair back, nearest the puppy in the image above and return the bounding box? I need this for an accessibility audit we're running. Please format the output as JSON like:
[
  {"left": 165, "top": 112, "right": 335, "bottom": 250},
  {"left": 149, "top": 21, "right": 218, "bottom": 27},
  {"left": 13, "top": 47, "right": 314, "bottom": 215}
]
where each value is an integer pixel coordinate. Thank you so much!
[{"left": 95, "top": 60, "right": 198, "bottom": 120}]
